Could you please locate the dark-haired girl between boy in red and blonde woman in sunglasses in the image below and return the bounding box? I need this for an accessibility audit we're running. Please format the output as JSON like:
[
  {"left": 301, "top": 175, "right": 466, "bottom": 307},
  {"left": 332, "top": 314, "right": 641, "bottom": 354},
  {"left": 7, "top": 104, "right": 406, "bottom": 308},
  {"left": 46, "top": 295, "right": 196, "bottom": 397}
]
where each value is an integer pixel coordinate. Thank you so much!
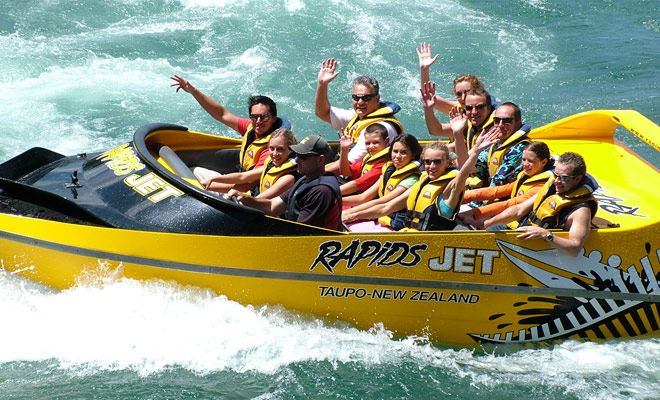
[{"left": 342, "top": 133, "right": 422, "bottom": 232}]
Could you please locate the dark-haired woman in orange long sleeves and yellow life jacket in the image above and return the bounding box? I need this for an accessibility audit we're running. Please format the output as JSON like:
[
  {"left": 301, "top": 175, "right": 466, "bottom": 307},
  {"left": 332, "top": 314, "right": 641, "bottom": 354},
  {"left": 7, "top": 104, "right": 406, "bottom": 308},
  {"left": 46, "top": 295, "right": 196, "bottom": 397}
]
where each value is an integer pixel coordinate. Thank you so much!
[{"left": 457, "top": 142, "right": 554, "bottom": 229}]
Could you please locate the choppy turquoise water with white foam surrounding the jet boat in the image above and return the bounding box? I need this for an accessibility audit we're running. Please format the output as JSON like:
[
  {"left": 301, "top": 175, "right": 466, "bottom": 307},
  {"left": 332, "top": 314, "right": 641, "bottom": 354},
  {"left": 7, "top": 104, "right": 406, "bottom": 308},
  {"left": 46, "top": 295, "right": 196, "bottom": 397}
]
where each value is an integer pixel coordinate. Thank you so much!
[{"left": 0, "top": 0, "right": 660, "bottom": 399}]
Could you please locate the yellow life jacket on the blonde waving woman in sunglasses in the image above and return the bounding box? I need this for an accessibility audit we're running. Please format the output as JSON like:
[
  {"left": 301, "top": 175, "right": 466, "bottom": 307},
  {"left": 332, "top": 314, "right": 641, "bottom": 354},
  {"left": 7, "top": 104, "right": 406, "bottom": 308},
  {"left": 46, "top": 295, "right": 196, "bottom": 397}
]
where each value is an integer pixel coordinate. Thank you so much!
[{"left": 405, "top": 169, "right": 465, "bottom": 231}]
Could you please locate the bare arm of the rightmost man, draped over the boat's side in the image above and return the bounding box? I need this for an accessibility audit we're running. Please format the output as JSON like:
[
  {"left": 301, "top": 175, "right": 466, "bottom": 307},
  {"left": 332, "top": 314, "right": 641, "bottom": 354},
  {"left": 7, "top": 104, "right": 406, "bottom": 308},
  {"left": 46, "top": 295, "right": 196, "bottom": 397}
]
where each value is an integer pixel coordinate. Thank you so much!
[{"left": 516, "top": 207, "right": 591, "bottom": 257}]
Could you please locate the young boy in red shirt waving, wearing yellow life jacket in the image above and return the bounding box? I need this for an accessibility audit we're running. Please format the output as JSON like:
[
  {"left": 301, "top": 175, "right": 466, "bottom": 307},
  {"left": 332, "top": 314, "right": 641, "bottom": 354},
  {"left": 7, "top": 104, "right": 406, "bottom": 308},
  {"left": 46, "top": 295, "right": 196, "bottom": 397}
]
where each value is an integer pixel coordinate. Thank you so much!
[{"left": 339, "top": 123, "right": 389, "bottom": 196}]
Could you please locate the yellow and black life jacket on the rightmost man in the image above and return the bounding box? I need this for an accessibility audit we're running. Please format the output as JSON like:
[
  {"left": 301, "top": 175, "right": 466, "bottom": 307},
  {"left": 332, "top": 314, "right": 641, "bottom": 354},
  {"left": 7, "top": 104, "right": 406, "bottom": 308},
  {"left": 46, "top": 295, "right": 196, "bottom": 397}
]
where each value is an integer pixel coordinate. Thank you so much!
[{"left": 527, "top": 177, "right": 598, "bottom": 229}]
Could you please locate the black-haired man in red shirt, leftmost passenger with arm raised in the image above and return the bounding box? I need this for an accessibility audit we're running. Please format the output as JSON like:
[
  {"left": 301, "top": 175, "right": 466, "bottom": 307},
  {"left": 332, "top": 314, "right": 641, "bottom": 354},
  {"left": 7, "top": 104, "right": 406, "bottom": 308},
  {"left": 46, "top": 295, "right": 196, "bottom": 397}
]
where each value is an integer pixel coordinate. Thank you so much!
[{"left": 170, "top": 75, "right": 291, "bottom": 175}]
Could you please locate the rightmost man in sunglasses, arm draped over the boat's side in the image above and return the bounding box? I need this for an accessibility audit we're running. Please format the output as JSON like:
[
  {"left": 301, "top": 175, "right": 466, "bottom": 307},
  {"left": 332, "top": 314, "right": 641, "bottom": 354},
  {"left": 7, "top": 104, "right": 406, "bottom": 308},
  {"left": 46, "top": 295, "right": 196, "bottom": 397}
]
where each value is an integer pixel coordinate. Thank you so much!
[{"left": 484, "top": 152, "right": 598, "bottom": 257}]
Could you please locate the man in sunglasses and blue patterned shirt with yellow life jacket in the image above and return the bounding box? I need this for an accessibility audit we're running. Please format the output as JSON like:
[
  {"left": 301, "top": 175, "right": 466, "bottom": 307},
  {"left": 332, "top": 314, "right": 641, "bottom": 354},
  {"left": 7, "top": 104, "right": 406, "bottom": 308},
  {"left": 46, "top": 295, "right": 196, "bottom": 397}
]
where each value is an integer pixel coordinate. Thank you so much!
[{"left": 476, "top": 102, "right": 529, "bottom": 186}]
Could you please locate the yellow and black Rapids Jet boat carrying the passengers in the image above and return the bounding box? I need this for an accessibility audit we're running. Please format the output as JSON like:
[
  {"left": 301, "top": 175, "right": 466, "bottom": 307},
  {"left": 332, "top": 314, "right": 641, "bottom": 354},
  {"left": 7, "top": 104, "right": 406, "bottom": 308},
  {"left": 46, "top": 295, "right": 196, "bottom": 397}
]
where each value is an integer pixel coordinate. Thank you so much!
[{"left": 0, "top": 111, "right": 660, "bottom": 346}]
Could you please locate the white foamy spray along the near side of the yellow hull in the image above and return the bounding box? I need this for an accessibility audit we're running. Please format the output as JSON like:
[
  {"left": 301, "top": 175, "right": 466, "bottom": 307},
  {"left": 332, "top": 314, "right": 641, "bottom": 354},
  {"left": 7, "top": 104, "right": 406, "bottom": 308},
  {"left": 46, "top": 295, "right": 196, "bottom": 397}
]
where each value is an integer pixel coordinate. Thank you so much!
[{"left": 0, "top": 268, "right": 660, "bottom": 399}]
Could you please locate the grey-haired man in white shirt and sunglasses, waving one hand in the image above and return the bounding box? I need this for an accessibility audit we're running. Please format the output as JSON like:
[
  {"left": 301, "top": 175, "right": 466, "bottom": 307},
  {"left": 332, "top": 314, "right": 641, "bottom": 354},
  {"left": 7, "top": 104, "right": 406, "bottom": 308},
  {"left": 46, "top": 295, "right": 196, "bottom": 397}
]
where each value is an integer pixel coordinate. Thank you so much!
[{"left": 314, "top": 58, "right": 403, "bottom": 167}]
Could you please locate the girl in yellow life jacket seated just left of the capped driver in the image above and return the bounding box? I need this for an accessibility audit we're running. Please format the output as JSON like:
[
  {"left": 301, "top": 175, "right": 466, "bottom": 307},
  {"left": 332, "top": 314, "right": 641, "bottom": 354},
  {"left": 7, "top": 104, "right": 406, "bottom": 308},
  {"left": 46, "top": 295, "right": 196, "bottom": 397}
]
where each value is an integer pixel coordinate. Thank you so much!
[{"left": 202, "top": 129, "right": 299, "bottom": 199}]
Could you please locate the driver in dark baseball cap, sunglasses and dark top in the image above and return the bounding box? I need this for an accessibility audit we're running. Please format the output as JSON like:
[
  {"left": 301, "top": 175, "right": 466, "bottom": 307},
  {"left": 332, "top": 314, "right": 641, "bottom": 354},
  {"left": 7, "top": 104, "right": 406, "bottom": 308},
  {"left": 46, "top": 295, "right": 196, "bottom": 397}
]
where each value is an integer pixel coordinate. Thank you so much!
[{"left": 225, "top": 135, "right": 341, "bottom": 230}]
